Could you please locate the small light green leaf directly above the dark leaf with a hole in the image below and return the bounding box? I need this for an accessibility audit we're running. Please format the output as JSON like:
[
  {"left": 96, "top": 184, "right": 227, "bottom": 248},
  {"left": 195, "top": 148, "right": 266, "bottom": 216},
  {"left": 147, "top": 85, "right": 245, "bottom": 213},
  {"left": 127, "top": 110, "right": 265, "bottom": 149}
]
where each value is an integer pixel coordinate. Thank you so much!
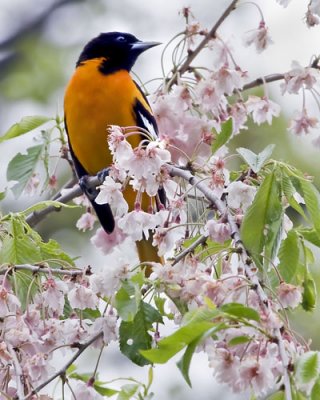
[{"left": 115, "top": 281, "right": 141, "bottom": 321}]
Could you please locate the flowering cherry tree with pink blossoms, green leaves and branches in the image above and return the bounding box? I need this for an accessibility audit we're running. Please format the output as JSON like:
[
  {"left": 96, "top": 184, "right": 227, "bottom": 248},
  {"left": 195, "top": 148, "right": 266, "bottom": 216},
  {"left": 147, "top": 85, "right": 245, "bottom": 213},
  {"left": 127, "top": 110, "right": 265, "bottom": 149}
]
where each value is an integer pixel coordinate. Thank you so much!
[{"left": 0, "top": 0, "right": 320, "bottom": 400}]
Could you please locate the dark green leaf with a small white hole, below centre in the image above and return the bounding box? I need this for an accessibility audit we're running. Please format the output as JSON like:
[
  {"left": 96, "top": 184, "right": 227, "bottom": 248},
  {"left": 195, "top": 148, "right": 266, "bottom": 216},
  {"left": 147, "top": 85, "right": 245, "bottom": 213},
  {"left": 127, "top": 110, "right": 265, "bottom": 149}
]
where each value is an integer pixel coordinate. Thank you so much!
[{"left": 119, "top": 302, "right": 162, "bottom": 366}]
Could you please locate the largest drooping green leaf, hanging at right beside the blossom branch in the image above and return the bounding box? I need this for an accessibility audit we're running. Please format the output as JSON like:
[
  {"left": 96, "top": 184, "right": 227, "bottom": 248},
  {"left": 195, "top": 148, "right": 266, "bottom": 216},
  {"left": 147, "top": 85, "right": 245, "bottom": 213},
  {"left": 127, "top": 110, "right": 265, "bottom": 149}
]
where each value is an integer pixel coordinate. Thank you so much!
[{"left": 240, "top": 172, "right": 283, "bottom": 258}]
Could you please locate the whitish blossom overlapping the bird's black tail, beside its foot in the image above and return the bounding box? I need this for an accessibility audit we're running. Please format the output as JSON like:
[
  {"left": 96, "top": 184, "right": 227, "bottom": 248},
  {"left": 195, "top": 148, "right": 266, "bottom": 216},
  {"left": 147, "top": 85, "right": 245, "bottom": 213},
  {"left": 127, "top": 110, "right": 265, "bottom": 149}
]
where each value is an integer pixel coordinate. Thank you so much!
[{"left": 95, "top": 176, "right": 129, "bottom": 217}]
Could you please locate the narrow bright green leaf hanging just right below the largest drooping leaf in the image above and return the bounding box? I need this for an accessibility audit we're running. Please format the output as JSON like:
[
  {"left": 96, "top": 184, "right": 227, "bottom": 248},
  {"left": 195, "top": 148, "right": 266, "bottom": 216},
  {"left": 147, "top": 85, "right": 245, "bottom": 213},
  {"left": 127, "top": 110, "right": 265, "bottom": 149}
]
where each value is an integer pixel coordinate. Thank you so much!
[{"left": 278, "top": 230, "right": 300, "bottom": 283}]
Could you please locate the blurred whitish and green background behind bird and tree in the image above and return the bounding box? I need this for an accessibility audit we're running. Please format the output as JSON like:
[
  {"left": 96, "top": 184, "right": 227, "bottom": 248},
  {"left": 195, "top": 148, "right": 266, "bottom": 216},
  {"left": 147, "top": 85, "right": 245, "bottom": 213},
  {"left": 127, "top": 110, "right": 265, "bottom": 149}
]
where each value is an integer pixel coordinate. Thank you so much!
[{"left": 0, "top": 0, "right": 320, "bottom": 400}]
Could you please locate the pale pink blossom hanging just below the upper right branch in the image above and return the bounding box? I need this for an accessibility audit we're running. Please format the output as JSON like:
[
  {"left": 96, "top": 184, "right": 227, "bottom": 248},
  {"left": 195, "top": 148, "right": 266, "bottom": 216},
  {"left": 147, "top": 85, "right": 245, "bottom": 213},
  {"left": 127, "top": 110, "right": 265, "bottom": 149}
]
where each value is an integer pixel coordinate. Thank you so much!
[{"left": 245, "top": 96, "right": 280, "bottom": 125}]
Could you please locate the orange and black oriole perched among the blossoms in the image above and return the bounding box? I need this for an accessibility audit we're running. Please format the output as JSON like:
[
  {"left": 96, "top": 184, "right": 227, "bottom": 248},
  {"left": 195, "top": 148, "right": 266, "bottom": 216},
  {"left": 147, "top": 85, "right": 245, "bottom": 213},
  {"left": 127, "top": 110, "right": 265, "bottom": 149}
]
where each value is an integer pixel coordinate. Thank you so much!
[{"left": 64, "top": 32, "right": 160, "bottom": 262}]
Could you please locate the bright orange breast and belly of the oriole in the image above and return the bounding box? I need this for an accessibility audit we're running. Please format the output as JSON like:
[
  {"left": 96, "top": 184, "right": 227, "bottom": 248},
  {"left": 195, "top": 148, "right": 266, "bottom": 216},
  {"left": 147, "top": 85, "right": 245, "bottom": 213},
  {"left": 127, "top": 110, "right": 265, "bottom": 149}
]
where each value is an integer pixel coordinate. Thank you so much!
[{"left": 64, "top": 59, "right": 151, "bottom": 175}]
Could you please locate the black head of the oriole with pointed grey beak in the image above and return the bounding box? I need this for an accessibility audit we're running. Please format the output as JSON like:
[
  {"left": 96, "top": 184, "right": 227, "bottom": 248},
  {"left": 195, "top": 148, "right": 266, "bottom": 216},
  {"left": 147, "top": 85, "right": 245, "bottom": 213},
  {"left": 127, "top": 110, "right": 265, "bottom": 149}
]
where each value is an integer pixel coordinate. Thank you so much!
[{"left": 77, "top": 32, "right": 160, "bottom": 72}]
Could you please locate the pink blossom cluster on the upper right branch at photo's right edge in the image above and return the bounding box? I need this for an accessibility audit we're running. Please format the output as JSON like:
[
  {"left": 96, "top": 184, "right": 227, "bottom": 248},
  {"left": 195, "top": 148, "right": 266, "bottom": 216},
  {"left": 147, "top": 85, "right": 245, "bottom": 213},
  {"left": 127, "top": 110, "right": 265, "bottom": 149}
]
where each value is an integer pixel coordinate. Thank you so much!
[{"left": 280, "top": 61, "right": 319, "bottom": 94}]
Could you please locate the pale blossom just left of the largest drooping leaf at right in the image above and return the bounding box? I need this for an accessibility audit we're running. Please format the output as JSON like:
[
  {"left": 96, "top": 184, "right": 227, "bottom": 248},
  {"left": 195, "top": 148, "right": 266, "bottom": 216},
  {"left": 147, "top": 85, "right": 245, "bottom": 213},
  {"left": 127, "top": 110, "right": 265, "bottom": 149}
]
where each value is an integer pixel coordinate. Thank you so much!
[{"left": 226, "top": 181, "right": 257, "bottom": 211}]
